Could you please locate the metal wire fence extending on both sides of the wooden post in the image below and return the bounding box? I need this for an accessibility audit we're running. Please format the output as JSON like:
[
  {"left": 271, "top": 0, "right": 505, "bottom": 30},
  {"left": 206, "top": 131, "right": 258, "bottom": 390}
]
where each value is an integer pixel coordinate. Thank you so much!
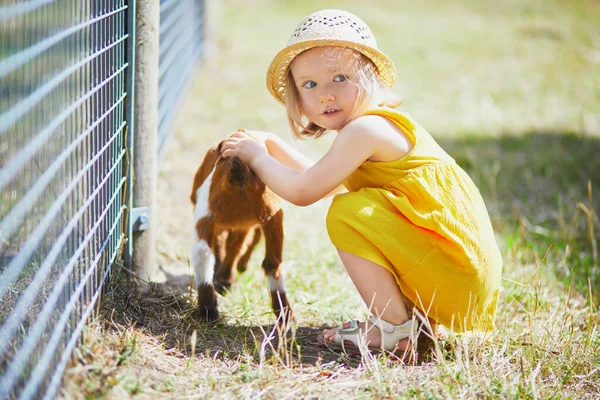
[{"left": 0, "top": 0, "right": 203, "bottom": 399}]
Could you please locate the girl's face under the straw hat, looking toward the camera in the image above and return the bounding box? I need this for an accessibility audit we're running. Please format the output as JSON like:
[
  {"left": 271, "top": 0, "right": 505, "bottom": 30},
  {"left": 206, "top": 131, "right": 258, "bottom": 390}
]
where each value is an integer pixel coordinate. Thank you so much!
[{"left": 290, "top": 47, "right": 358, "bottom": 130}]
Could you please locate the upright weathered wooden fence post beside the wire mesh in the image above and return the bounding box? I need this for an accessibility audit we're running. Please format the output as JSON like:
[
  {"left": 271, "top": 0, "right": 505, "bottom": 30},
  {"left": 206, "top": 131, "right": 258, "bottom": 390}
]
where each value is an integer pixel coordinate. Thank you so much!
[{"left": 130, "top": 0, "right": 160, "bottom": 281}]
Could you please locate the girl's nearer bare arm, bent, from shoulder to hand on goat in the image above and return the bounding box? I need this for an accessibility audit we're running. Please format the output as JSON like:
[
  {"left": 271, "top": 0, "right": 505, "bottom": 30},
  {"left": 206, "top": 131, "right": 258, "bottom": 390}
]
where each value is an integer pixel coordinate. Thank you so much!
[{"left": 222, "top": 124, "right": 381, "bottom": 206}]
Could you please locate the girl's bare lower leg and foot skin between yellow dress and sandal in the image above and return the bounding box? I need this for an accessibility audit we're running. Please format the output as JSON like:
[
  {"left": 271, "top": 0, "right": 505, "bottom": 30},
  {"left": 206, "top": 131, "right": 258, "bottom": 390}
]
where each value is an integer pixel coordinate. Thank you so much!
[{"left": 323, "top": 250, "right": 410, "bottom": 348}]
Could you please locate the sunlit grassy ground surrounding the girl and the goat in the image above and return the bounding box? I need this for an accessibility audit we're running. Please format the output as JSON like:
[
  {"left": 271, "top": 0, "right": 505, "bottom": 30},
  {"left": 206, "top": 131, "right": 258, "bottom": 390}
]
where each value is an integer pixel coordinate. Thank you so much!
[{"left": 60, "top": 0, "right": 600, "bottom": 399}]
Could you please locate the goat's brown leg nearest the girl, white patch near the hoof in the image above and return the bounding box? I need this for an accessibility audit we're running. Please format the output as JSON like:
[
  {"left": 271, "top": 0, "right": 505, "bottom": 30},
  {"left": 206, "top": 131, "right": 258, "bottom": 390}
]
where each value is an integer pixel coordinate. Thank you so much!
[{"left": 262, "top": 210, "right": 292, "bottom": 322}]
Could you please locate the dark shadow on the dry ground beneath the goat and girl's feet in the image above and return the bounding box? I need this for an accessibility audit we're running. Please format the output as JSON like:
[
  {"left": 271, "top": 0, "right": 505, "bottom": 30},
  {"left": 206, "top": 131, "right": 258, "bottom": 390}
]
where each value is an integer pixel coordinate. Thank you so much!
[{"left": 101, "top": 277, "right": 432, "bottom": 367}]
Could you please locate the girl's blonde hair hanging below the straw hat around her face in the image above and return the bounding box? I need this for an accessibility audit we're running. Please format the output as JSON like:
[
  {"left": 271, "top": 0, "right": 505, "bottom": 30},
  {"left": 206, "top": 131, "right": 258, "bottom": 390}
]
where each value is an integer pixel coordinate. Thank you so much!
[{"left": 285, "top": 46, "right": 402, "bottom": 139}]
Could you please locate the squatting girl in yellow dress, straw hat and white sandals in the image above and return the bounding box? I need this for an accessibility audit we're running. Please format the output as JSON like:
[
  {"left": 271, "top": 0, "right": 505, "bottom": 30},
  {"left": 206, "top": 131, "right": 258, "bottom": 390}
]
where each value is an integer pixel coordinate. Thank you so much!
[{"left": 222, "top": 10, "right": 502, "bottom": 360}]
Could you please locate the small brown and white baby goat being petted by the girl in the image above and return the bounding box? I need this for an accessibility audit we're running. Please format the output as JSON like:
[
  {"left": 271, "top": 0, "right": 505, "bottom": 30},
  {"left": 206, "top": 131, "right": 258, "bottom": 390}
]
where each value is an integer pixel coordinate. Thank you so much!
[{"left": 190, "top": 142, "right": 291, "bottom": 322}]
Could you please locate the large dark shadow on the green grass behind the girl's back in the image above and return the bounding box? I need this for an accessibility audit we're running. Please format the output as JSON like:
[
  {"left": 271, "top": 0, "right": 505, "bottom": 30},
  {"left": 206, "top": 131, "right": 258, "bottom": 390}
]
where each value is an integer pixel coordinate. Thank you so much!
[{"left": 438, "top": 132, "right": 600, "bottom": 293}]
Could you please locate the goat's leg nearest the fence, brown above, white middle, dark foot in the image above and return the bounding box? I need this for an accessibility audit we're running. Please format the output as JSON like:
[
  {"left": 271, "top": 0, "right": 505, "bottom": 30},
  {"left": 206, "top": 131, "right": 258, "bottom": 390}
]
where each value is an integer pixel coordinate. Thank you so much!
[{"left": 190, "top": 216, "right": 219, "bottom": 322}]
